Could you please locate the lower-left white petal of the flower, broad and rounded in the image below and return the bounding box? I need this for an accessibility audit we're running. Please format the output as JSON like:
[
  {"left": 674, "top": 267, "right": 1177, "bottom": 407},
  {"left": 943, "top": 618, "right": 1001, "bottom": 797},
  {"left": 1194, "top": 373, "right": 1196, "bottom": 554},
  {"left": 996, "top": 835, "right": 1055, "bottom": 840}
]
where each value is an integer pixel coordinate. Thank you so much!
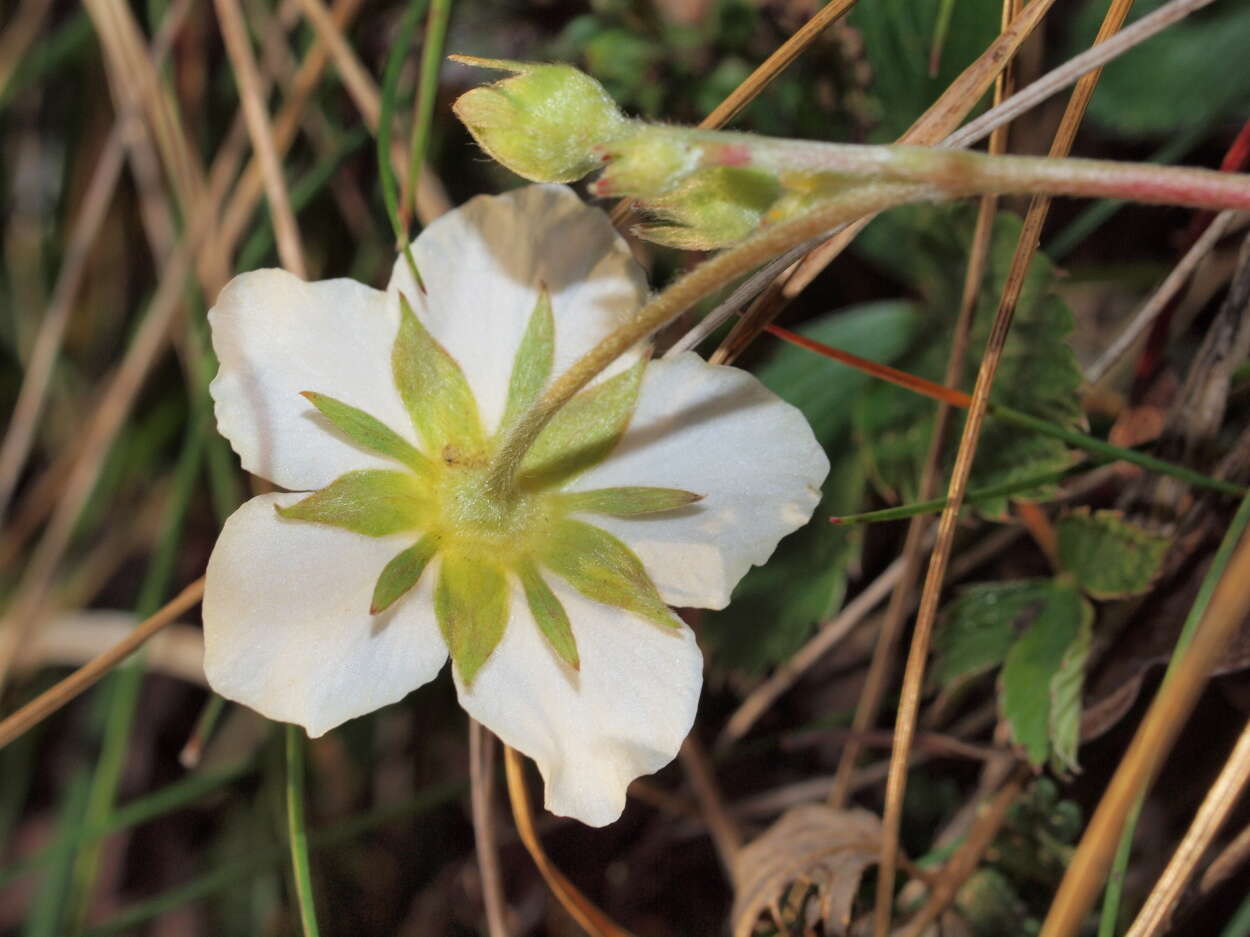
[{"left": 204, "top": 493, "right": 448, "bottom": 736}]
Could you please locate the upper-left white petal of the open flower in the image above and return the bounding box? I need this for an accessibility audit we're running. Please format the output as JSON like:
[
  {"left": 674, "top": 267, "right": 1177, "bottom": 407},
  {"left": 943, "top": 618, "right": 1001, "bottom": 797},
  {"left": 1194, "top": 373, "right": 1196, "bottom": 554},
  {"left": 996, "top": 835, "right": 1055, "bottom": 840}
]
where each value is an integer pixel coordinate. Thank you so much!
[{"left": 209, "top": 270, "right": 416, "bottom": 491}]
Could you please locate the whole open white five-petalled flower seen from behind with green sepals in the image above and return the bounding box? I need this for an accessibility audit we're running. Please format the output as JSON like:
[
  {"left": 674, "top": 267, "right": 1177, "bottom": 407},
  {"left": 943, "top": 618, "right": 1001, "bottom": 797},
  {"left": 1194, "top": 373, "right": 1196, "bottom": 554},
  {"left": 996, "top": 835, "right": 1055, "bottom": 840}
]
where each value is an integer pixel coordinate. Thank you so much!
[{"left": 204, "top": 186, "right": 829, "bottom": 826}]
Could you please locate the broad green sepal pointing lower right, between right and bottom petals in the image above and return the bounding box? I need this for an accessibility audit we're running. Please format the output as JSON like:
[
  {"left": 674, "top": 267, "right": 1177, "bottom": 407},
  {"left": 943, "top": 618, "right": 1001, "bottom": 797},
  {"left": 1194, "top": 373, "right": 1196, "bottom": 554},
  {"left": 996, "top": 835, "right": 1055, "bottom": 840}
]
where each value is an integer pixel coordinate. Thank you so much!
[{"left": 538, "top": 520, "right": 680, "bottom": 627}]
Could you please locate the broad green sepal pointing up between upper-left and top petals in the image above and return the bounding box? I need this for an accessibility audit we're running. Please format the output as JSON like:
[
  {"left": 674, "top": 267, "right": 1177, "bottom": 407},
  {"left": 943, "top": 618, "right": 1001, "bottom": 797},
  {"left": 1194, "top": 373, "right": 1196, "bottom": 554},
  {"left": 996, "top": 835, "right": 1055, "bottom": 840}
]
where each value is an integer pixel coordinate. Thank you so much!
[{"left": 391, "top": 294, "right": 488, "bottom": 455}]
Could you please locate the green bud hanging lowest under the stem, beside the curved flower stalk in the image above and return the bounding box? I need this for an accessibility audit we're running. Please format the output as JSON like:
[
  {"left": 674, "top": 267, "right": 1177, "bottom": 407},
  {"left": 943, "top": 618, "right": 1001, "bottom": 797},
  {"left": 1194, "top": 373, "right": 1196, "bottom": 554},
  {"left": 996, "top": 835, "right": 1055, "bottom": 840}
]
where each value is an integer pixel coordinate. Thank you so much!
[{"left": 636, "top": 167, "right": 781, "bottom": 251}]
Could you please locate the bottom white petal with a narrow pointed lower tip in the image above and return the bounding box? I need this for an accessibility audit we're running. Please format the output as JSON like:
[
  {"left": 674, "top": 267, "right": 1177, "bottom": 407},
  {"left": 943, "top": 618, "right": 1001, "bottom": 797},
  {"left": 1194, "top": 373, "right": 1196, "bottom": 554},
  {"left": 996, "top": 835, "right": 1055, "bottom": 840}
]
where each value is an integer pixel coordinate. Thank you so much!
[{"left": 456, "top": 575, "right": 703, "bottom": 826}]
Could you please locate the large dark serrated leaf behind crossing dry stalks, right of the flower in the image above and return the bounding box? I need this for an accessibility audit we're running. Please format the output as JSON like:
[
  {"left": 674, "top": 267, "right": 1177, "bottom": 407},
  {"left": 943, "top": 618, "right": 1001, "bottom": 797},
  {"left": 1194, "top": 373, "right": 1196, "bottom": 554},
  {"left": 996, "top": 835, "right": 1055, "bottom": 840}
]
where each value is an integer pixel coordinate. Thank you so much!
[{"left": 854, "top": 206, "right": 1084, "bottom": 517}]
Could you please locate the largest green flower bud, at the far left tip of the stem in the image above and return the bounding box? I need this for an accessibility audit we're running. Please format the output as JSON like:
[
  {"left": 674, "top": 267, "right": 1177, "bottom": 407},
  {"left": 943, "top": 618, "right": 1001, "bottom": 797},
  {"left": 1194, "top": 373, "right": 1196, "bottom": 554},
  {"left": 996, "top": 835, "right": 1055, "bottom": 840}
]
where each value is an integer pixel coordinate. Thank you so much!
[{"left": 451, "top": 55, "right": 630, "bottom": 182}]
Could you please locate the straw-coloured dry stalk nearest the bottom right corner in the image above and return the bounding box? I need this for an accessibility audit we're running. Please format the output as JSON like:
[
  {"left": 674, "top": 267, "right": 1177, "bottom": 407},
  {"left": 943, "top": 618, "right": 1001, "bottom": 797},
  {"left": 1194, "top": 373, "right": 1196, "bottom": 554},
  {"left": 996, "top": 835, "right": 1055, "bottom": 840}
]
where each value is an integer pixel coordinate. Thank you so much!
[{"left": 1125, "top": 722, "right": 1250, "bottom": 937}]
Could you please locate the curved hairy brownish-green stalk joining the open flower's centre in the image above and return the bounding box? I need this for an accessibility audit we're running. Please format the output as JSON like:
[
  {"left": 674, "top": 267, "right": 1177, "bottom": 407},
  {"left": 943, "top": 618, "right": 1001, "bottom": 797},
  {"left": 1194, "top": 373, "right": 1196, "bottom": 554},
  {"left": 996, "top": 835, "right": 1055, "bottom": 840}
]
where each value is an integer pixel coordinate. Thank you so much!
[{"left": 488, "top": 177, "right": 925, "bottom": 500}]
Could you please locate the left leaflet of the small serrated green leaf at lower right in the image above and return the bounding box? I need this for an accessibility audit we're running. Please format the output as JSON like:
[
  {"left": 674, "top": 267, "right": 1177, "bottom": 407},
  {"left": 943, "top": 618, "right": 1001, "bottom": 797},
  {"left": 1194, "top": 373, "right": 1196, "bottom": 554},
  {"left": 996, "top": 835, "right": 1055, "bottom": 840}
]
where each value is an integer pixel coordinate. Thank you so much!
[{"left": 934, "top": 580, "right": 1054, "bottom": 685}]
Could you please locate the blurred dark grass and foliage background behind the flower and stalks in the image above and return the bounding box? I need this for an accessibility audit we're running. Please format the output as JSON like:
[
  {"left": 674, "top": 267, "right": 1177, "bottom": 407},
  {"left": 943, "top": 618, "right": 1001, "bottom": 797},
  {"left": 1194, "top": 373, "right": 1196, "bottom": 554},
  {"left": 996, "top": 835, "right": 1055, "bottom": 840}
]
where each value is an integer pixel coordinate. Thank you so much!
[{"left": 0, "top": 0, "right": 1250, "bottom": 937}]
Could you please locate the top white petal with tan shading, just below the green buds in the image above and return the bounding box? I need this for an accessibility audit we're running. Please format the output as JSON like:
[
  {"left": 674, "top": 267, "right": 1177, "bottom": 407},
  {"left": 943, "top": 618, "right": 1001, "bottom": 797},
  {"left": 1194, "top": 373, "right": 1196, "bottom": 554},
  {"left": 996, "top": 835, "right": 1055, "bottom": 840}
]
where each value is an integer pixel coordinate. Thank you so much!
[{"left": 388, "top": 185, "right": 648, "bottom": 432}]
